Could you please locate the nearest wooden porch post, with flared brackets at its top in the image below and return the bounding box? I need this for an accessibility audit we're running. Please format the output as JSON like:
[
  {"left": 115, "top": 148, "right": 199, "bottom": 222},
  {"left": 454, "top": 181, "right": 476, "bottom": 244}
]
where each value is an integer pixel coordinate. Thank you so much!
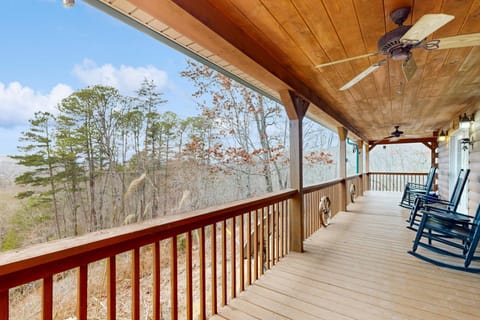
[{"left": 280, "top": 90, "right": 310, "bottom": 252}]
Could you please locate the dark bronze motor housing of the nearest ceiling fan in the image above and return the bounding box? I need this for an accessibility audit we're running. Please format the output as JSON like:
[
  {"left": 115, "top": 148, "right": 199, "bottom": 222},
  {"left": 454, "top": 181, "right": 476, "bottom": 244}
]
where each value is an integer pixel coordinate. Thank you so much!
[{"left": 377, "top": 26, "right": 412, "bottom": 60}]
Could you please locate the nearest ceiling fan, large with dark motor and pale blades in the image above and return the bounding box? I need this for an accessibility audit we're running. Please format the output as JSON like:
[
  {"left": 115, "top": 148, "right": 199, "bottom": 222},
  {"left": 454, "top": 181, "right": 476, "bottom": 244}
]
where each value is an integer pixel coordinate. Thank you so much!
[{"left": 315, "top": 7, "right": 480, "bottom": 91}]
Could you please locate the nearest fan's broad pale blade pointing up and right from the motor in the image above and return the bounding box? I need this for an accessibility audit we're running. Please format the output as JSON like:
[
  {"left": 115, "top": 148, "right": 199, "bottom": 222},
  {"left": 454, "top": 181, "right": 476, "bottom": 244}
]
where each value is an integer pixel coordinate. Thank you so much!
[{"left": 400, "top": 13, "right": 455, "bottom": 44}]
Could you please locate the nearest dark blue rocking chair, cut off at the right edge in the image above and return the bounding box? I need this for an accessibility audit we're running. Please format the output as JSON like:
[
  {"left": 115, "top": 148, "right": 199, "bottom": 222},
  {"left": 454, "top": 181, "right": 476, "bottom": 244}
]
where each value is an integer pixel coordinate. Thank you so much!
[{"left": 409, "top": 205, "right": 480, "bottom": 273}]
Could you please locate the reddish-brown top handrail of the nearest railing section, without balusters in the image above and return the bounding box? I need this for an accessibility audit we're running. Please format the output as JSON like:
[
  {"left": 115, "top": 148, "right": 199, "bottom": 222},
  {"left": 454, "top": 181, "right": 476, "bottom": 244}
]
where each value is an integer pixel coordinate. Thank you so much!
[{"left": 0, "top": 189, "right": 297, "bottom": 284}]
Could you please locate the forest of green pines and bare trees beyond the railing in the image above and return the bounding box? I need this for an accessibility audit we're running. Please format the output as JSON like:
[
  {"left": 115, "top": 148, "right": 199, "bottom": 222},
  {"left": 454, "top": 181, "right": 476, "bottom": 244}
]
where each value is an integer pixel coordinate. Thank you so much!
[{"left": 0, "top": 61, "right": 338, "bottom": 251}]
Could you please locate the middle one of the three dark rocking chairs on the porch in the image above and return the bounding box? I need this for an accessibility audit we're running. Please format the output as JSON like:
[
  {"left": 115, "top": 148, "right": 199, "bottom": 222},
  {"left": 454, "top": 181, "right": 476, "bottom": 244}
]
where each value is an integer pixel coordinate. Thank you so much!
[{"left": 407, "top": 169, "right": 470, "bottom": 231}]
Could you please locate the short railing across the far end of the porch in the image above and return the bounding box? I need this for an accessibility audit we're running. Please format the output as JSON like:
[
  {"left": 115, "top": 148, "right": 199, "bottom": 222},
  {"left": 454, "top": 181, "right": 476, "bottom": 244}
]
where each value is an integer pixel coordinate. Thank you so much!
[{"left": 368, "top": 172, "right": 428, "bottom": 192}]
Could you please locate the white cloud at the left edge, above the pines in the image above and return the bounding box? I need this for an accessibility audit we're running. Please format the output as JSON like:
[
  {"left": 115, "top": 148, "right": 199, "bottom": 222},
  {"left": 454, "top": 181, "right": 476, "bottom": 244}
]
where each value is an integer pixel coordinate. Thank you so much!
[{"left": 0, "top": 82, "right": 73, "bottom": 127}]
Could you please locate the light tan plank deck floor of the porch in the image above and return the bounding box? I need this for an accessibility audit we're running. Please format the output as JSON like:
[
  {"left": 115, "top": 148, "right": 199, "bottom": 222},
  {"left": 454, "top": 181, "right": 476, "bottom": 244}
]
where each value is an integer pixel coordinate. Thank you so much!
[{"left": 212, "top": 192, "right": 480, "bottom": 320}]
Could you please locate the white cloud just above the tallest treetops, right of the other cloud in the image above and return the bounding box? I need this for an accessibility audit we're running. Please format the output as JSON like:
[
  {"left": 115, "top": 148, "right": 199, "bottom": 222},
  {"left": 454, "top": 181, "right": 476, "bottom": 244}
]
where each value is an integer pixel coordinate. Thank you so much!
[{"left": 73, "top": 59, "right": 168, "bottom": 94}]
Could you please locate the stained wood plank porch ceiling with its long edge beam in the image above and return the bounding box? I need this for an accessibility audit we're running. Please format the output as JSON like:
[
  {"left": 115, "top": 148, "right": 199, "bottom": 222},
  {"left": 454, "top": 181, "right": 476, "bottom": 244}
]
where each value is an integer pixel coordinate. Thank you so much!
[{"left": 94, "top": 0, "right": 480, "bottom": 141}]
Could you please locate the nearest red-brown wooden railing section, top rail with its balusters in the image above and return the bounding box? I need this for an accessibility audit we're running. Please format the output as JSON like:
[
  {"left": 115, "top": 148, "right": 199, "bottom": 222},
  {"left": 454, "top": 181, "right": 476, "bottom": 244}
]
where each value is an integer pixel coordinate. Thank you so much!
[{"left": 0, "top": 189, "right": 298, "bottom": 320}]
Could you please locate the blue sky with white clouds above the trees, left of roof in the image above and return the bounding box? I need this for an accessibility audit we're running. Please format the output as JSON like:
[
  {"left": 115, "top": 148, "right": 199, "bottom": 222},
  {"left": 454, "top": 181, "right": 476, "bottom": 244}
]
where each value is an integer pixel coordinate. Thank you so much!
[{"left": 0, "top": 0, "right": 196, "bottom": 154}]
